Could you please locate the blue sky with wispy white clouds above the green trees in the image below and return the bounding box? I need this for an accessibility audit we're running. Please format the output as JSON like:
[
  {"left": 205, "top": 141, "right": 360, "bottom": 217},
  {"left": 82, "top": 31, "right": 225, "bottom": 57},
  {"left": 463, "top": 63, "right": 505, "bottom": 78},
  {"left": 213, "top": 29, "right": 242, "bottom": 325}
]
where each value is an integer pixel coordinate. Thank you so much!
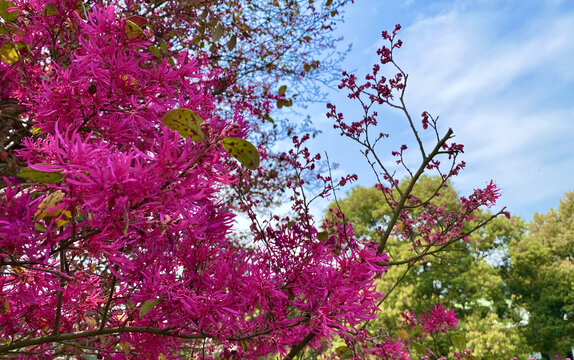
[{"left": 305, "top": 0, "right": 574, "bottom": 220}]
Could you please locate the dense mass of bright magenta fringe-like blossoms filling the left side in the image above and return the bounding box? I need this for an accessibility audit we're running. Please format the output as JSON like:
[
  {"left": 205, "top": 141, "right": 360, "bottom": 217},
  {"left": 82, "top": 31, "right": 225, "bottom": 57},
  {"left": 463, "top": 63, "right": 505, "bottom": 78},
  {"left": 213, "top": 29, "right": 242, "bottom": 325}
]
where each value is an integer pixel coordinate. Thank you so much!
[{"left": 0, "top": 0, "right": 388, "bottom": 359}]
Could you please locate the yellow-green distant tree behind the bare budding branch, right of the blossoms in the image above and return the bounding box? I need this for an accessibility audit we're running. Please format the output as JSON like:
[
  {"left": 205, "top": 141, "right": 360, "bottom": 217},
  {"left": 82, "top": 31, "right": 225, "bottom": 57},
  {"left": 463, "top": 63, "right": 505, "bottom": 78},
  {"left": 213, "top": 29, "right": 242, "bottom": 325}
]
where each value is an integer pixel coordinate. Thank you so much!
[{"left": 331, "top": 176, "right": 529, "bottom": 360}]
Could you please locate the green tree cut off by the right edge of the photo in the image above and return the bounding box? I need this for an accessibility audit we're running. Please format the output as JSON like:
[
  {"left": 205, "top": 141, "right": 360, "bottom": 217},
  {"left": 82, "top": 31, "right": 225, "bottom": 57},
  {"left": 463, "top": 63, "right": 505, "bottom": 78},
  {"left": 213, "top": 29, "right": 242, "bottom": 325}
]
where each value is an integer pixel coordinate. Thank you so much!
[{"left": 507, "top": 192, "right": 574, "bottom": 354}]
